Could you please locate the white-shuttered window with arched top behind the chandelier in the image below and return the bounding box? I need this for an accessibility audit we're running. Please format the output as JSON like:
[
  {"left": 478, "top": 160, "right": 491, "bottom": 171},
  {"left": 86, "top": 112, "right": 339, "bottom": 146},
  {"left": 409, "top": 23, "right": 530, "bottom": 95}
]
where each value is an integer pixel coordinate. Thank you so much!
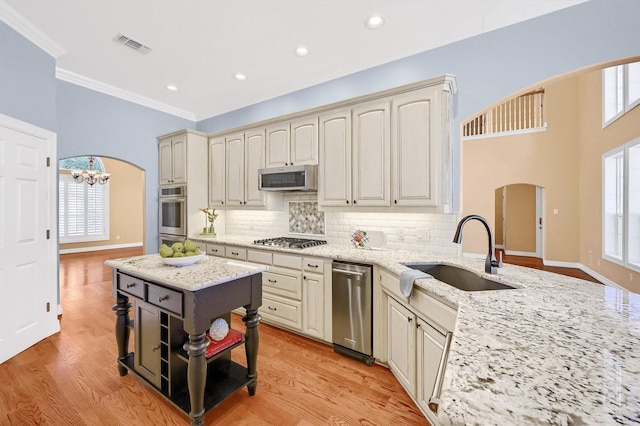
[{"left": 58, "top": 157, "right": 109, "bottom": 244}]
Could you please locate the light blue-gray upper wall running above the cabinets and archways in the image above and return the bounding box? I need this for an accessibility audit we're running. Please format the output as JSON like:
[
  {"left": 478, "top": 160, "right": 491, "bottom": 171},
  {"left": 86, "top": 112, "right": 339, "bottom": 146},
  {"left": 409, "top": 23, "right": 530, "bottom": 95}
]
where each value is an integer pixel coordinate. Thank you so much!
[{"left": 0, "top": 0, "right": 640, "bottom": 251}]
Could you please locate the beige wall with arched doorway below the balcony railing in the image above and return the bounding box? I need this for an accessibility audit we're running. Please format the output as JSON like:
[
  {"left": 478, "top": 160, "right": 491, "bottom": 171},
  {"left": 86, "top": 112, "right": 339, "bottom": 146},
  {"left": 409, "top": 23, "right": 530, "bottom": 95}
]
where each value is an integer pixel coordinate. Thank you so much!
[{"left": 461, "top": 78, "right": 579, "bottom": 262}]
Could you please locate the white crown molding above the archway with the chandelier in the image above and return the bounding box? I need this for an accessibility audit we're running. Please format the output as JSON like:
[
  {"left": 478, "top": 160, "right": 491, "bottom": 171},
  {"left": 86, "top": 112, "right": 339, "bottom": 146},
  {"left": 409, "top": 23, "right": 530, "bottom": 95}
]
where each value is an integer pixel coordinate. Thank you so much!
[{"left": 56, "top": 68, "right": 196, "bottom": 122}]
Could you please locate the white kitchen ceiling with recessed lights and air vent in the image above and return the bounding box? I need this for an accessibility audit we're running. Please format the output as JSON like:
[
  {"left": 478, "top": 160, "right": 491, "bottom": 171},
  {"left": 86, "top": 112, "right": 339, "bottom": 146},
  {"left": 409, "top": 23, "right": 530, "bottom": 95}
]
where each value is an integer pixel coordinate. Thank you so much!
[{"left": 0, "top": 0, "right": 584, "bottom": 120}]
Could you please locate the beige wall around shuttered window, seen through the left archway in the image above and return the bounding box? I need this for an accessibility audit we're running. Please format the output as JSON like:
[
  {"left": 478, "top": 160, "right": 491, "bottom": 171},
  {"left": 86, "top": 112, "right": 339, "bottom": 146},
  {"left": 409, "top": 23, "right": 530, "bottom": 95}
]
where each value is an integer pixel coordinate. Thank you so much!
[{"left": 60, "top": 157, "right": 145, "bottom": 250}]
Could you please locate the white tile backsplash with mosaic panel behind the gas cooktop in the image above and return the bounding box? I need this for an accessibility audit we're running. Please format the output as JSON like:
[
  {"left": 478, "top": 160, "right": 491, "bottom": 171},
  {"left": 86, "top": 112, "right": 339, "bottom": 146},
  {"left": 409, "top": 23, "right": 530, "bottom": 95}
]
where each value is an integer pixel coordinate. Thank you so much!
[{"left": 222, "top": 194, "right": 460, "bottom": 256}]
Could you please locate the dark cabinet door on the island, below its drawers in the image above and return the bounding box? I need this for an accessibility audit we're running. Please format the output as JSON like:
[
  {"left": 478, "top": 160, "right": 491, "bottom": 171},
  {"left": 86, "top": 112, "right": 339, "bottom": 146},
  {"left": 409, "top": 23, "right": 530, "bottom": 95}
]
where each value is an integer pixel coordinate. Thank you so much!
[{"left": 133, "top": 299, "right": 161, "bottom": 387}]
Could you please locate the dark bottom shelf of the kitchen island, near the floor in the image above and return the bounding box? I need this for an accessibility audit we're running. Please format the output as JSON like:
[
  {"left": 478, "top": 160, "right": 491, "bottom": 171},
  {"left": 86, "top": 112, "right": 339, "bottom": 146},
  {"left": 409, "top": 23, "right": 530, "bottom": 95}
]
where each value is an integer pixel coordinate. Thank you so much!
[{"left": 118, "top": 352, "right": 255, "bottom": 415}]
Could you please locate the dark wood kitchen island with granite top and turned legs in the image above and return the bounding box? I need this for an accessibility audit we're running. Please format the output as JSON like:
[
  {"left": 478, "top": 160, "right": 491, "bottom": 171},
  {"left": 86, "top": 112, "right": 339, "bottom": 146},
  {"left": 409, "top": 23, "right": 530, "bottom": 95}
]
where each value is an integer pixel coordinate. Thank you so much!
[{"left": 105, "top": 255, "right": 266, "bottom": 425}]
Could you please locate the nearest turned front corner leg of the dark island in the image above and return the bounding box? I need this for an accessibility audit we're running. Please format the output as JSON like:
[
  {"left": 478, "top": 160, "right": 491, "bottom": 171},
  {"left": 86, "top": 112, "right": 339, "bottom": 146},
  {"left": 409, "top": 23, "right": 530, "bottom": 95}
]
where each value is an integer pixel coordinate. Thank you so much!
[{"left": 183, "top": 333, "right": 209, "bottom": 426}]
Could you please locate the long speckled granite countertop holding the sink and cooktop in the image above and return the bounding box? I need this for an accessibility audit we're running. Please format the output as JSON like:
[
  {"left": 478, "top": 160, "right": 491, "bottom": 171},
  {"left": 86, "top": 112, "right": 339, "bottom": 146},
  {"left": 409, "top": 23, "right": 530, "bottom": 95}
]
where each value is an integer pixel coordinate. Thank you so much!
[{"left": 192, "top": 236, "right": 640, "bottom": 426}]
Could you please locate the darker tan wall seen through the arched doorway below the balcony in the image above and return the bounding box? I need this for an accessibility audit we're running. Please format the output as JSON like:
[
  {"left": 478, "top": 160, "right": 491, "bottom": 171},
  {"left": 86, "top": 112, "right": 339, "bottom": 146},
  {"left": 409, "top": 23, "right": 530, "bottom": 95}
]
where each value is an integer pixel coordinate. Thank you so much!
[{"left": 505, "top": 184, "right": 536, "bottom": 254}]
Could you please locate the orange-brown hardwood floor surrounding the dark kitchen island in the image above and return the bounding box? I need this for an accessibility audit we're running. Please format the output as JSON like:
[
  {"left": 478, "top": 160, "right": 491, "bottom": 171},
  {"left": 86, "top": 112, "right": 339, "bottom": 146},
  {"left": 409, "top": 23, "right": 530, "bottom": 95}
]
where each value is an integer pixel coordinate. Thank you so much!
[{"left": 0, "top": 249, "right": 429, "bottom": 426}]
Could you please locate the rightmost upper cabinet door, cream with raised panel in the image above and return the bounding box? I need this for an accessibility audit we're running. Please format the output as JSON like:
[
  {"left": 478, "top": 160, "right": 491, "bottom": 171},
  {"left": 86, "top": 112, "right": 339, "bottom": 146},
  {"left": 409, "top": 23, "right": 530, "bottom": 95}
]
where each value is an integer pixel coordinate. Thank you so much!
[{"left": 392, "top": 89, "right": 437, "bottom": 206}]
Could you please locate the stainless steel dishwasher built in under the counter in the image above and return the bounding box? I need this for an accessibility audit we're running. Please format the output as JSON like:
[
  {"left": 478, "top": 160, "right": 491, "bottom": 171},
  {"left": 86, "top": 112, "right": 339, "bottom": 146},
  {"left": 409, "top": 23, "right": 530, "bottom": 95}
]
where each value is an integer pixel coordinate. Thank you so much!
[{"left": 331, "top": 262, "right": 374, "bottom": 365}]
